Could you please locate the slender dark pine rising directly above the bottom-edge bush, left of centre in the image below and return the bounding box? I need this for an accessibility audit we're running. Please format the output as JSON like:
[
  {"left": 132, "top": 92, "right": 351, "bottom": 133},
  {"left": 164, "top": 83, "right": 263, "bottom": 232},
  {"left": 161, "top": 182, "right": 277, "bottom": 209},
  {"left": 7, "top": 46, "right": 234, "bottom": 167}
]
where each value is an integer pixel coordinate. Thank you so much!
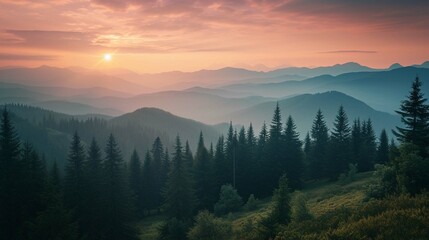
[{"left": 194, "top": 132, "right": 215, "bottom": 210}]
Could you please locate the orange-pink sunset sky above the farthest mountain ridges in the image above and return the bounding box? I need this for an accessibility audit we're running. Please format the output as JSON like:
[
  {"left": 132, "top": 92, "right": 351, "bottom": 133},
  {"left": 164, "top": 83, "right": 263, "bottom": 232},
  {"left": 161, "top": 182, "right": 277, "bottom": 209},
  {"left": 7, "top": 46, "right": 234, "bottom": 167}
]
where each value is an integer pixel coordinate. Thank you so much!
[{"left": 0, "top": 0, "right": 429, "bottom": 73}]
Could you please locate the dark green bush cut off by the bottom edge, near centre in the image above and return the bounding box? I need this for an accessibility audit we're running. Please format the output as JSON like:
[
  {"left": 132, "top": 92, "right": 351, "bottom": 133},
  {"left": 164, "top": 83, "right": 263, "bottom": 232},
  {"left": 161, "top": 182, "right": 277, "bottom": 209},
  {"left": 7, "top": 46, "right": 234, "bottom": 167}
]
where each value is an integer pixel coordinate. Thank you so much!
[{"left": 188, "top": 211, "right": 232, "bottom": 240}]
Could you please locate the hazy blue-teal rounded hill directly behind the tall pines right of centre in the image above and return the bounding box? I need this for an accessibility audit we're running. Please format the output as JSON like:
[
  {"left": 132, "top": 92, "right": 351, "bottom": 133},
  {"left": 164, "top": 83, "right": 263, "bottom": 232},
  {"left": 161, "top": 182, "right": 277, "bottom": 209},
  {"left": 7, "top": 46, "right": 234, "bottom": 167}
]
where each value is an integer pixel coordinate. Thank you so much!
[{"left": 231, "top": 91, "right": 400, "bottom": 138}]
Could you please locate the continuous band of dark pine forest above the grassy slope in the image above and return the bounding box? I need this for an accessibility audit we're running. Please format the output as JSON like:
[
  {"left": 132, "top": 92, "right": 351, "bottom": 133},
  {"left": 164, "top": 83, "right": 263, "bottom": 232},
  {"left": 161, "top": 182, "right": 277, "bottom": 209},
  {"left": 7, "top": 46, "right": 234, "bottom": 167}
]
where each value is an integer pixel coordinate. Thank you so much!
[{"left": 0, "top": 79, "right": 429, "bottom": 239}]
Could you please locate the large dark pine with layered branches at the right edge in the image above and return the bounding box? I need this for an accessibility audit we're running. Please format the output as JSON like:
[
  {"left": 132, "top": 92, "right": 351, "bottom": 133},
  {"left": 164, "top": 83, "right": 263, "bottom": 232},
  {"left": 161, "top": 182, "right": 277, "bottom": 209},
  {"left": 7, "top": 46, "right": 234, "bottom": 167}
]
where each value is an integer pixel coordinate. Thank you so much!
[{"left": 393, "top": 77, "right": 429, "bottom": 156}]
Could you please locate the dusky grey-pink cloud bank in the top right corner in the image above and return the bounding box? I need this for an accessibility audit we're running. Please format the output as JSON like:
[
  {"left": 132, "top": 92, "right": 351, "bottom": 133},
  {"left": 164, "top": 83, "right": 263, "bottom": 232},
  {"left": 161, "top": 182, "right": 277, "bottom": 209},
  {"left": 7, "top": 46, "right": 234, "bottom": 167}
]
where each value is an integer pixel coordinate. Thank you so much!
[{"left": 273, "top": 0, "right": 429, "bottom": 29}]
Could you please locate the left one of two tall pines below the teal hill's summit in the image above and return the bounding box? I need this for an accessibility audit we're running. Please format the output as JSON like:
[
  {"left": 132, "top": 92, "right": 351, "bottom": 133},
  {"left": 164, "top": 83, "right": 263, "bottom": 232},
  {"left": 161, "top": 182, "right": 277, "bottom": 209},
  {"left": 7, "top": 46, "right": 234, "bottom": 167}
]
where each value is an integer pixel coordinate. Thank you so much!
[{"left": 309, "top": 109, "right": 329, "bottom": 179}]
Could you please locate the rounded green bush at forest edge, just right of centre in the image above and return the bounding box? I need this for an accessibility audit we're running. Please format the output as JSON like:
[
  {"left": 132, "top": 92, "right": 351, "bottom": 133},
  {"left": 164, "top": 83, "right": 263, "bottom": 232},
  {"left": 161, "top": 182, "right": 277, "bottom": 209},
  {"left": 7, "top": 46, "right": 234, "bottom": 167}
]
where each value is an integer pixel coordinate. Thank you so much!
[{"left": 214, "top": 184, "right": 243, "bottom": 216}]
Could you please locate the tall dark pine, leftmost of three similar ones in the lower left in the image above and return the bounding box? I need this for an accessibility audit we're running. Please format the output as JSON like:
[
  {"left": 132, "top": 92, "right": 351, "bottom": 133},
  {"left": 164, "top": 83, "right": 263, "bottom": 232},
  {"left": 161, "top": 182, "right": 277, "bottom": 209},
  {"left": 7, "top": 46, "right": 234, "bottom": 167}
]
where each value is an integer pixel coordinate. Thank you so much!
[{"left": 64, "top": 132, "right": 86, "bottom": 235}]
